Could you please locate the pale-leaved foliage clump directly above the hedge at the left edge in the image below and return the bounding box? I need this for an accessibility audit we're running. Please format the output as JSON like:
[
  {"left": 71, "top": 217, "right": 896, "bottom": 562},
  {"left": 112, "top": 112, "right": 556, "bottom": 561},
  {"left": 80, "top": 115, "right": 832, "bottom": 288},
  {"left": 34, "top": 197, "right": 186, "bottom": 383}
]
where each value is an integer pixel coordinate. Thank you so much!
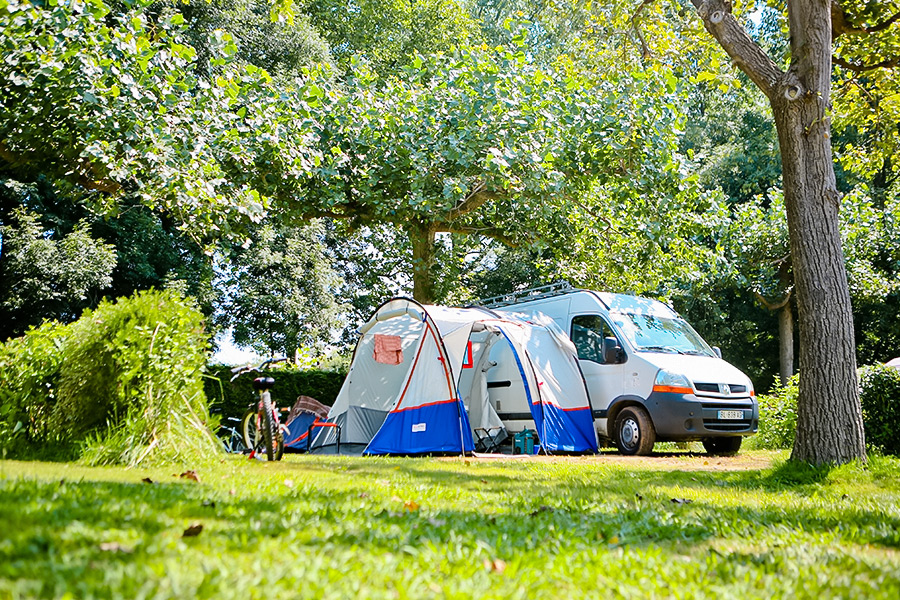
[{"left": 0, "top": 209, "right": 116, "bottom": 339}]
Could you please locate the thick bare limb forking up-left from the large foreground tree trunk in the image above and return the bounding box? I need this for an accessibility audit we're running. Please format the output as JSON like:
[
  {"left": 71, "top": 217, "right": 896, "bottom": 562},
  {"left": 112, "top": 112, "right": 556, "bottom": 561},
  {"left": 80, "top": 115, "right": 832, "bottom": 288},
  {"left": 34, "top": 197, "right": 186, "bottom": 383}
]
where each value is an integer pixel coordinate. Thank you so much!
[{"left": 691, "top": 0, "right": 784, "bottom": 99}]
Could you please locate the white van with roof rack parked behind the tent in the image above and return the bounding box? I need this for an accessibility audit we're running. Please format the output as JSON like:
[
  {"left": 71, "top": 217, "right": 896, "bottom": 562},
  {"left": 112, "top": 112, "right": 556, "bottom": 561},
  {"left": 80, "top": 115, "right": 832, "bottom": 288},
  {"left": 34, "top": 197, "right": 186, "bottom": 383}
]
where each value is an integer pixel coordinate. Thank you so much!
[{"left": 482, "top": 284, "right": 759, "bottom": 454}]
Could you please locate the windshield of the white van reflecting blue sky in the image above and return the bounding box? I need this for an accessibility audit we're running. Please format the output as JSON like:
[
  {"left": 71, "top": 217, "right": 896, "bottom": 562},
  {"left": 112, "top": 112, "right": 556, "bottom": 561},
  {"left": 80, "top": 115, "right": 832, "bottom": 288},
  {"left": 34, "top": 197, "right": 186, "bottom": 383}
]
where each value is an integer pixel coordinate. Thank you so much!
[{"left": 610, "top": 313, "right": 715, "bottom": 356}]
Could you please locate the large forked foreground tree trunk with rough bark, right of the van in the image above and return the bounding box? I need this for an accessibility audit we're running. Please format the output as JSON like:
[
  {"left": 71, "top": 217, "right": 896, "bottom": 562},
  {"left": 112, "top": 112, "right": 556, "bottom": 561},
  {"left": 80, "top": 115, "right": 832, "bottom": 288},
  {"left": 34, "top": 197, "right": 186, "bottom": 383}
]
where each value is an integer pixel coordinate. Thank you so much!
[{"left": 692, "top": 0, "right": 866, "bottom": 464}]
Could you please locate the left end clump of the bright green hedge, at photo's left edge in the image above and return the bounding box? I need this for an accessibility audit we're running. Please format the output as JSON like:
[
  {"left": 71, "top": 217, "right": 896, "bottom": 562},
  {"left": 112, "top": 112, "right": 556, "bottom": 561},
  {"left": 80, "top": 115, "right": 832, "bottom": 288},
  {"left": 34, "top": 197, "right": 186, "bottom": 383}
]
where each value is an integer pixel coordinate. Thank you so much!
[{"left": 0, "top": 321, "right": 69, "bottom": 456}]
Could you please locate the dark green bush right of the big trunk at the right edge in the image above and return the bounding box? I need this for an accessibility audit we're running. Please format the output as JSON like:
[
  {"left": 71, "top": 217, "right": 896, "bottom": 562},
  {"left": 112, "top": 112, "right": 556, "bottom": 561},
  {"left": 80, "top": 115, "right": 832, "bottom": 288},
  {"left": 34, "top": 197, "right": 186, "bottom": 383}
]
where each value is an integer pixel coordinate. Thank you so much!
[{"left": 859, "top": 365, "right": 900, "bottom": 455}]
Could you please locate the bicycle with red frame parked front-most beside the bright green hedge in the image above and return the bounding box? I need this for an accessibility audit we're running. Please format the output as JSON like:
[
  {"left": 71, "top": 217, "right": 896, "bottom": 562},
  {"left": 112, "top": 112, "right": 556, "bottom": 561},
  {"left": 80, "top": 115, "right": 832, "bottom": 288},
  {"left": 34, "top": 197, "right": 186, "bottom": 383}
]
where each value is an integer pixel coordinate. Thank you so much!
[{"left": 231, "top": 358, "right": 287, "bottom": 460}]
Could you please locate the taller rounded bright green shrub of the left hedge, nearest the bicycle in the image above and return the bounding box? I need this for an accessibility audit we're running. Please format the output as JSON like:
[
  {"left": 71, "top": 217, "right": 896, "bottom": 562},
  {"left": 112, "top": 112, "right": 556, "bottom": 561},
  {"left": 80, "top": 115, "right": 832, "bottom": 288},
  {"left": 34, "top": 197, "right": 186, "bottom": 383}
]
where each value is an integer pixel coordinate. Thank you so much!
[{"left": 49, "top": 290, "right": 219, "bottom": 465}]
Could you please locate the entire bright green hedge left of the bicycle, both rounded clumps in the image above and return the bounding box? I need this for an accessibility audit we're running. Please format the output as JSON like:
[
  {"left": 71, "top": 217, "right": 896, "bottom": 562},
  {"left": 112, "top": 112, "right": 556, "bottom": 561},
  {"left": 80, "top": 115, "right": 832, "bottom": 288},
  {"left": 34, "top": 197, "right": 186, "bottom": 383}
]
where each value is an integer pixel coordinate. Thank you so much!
[{"left": 0, "top": 290, "right": 220, "bottom": 465}]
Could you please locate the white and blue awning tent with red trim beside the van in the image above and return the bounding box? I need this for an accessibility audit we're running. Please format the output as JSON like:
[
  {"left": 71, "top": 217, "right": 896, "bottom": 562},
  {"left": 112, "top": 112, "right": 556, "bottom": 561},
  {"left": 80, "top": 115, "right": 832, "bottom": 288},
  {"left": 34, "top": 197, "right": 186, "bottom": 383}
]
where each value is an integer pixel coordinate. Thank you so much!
[{"left": 314, "top": 298, "right": 597, "bottom": 454}]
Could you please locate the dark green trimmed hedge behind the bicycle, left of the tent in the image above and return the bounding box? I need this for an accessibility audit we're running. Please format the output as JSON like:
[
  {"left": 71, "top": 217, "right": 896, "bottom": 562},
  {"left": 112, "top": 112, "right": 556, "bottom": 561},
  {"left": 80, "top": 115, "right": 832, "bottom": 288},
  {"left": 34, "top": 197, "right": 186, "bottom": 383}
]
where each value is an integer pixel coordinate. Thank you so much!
[{"left": 203, "top": 365, "right": 347, "bottom": 417}]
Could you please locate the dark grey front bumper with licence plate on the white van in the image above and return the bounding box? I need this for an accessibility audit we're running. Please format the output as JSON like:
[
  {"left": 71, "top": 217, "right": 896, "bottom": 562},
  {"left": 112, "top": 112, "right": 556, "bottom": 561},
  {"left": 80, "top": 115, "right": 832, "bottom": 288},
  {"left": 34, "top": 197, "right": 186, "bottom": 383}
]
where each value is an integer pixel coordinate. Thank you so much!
[{"left": 646, "top": 392, "right": 759, "bottom": 441}]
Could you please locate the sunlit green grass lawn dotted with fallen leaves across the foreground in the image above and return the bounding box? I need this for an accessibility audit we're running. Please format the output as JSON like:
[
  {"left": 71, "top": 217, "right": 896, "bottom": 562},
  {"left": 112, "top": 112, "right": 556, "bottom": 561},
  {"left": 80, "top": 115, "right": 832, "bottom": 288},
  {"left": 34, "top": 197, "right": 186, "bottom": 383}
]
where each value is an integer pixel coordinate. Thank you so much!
[{"left": 0, "top": 453, "right": 900, "bottom": 600}]
